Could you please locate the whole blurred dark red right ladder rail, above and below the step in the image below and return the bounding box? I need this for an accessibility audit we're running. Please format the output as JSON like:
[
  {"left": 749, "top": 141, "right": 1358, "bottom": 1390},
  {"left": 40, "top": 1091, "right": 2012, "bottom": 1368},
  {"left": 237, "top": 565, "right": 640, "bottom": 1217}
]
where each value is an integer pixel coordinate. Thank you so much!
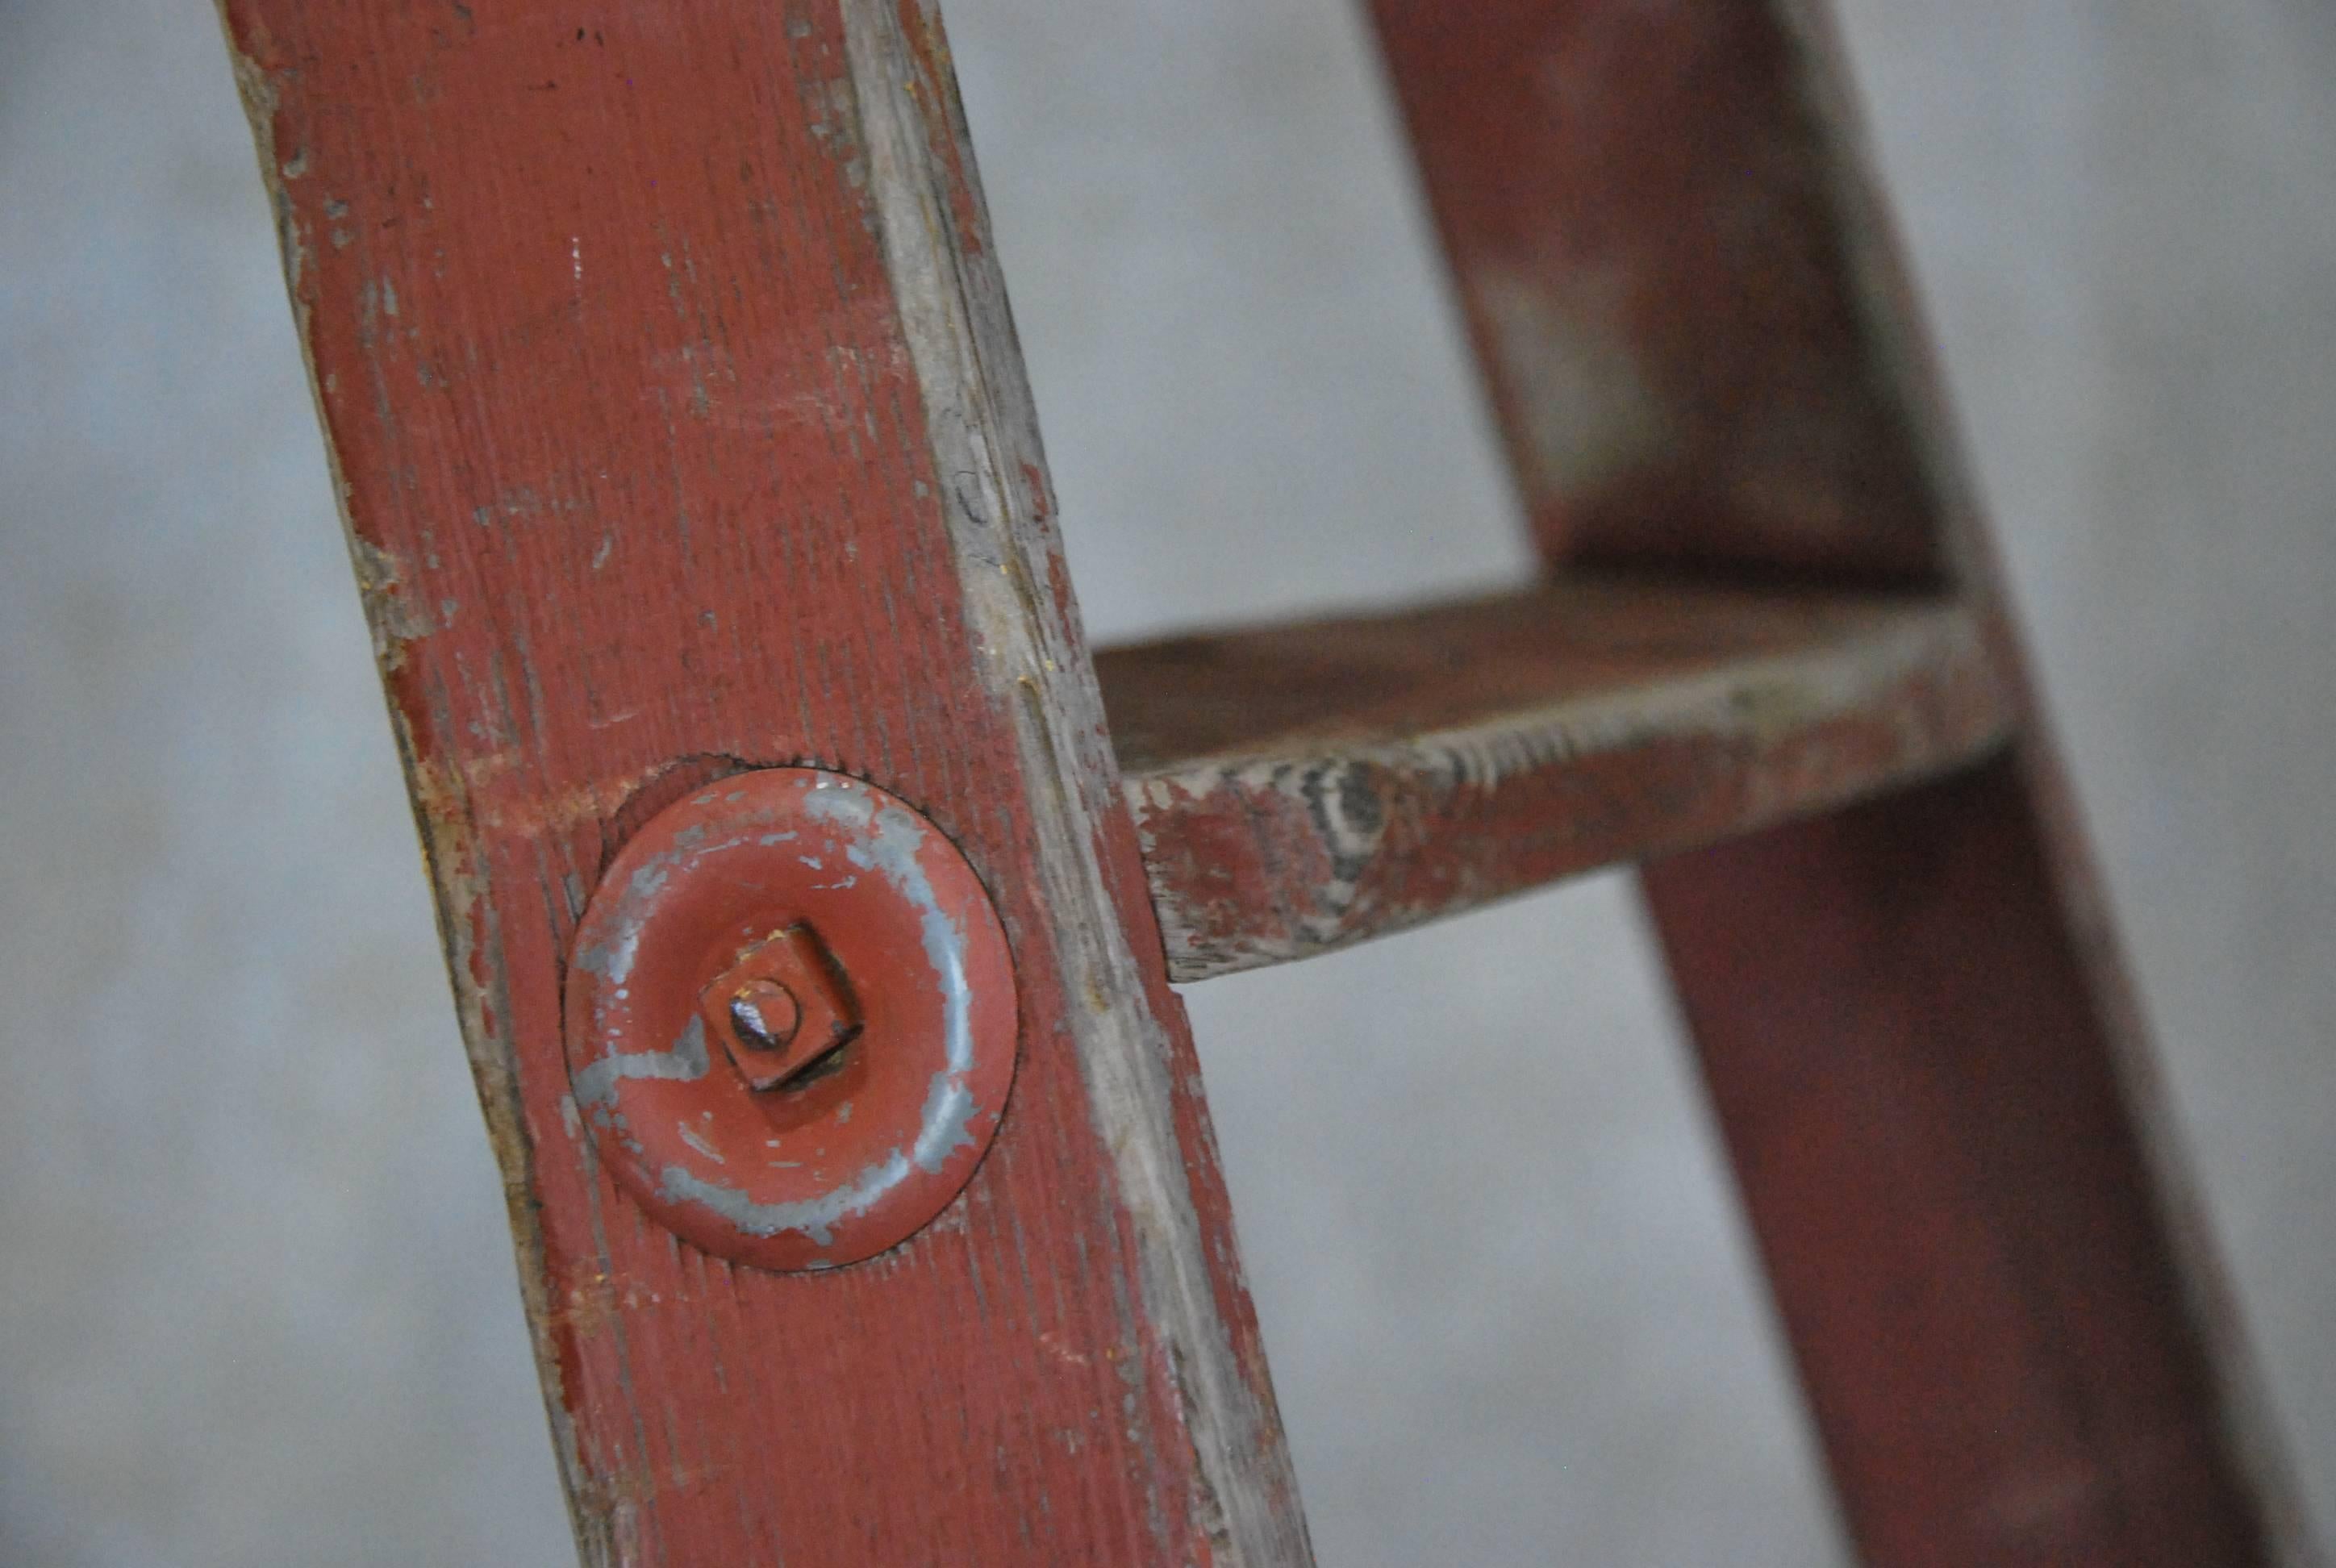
[{"left": 1374, "top": 0, "right": 2315, "bottom": 1568}]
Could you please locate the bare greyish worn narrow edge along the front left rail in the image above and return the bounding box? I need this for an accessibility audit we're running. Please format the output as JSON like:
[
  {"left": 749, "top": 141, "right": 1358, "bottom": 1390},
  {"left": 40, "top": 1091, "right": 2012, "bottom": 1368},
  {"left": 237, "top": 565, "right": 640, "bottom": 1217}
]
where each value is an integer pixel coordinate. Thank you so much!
[{"left": 841, "top": 0, "right": 1313, "bottom": 1568}]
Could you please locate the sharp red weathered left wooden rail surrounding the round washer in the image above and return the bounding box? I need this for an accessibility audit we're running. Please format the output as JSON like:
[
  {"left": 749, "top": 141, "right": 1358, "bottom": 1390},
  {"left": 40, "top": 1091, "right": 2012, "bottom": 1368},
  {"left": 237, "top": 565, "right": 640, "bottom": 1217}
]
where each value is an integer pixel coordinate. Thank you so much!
[{"left": 224, "top": 0, "right": 1306, "bottom": 1566}]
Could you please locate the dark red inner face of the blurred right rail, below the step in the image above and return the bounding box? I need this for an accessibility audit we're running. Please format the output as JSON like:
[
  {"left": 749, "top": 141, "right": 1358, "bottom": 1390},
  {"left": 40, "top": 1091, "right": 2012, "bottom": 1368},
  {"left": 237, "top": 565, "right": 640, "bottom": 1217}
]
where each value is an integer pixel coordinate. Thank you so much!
[{"left": 1647, "top": 760, "right": 2298, "bottom": 1568}]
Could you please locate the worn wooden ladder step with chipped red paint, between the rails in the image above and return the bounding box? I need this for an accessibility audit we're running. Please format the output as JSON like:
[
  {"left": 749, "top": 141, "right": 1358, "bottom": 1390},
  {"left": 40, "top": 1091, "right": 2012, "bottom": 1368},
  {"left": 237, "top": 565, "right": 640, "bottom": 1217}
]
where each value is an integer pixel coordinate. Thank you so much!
[{"left": 1095, "top": 573, "right": 2016, "bottom": 979}]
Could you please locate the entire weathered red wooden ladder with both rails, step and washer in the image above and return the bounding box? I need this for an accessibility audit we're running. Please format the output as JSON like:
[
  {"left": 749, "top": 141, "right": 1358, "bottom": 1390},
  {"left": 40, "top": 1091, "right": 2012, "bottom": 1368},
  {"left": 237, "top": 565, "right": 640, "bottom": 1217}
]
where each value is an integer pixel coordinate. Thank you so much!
[{"left": 222, "top": 0, "right": 2305, "bottom": 1568}]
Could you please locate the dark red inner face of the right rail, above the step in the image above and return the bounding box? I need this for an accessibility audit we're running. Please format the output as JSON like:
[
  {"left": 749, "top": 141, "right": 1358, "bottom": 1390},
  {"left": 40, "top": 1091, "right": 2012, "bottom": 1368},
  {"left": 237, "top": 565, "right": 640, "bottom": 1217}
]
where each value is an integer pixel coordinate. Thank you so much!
[{"left": 1371, "top": 0, "right": 1942, "bottom": 582}]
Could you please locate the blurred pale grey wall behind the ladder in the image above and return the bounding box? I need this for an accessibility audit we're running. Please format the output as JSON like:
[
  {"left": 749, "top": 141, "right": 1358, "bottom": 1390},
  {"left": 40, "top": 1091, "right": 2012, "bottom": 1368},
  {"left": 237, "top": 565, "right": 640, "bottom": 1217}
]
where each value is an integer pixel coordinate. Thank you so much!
[{"left": 0, "top": 0, "right": 2336, "bottom": 1568}]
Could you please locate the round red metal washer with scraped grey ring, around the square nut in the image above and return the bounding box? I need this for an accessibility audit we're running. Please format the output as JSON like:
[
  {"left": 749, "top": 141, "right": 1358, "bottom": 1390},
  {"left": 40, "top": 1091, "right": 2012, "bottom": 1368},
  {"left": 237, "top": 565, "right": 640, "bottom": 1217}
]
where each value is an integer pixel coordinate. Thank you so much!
[{"left": 565, "top": 769, "right": 1016, "bottom": 1269}]
